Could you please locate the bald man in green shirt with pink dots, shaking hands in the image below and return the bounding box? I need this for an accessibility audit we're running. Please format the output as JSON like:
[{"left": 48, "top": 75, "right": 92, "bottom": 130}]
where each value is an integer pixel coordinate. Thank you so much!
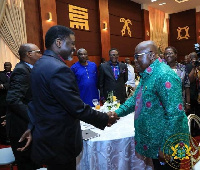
[{"left": 113, "top": 41, "right": 189, "bottom": 170}]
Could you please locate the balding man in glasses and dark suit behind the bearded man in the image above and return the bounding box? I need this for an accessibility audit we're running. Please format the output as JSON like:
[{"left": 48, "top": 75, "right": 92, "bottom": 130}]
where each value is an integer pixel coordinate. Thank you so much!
[{"left": 6, "top": 44, "right": 41, "bottom": 170}]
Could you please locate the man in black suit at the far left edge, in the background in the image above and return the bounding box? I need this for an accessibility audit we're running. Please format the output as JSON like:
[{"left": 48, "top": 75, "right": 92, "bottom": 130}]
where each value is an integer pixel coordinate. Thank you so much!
[{"left": 0, "top": 62, "right": 12, "bottom": 145}]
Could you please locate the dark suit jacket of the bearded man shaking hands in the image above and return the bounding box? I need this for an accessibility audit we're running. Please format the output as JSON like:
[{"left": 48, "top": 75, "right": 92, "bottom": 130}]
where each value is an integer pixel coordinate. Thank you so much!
[{"left": 29, "top": 50, "right": 108, "bottom": 164}]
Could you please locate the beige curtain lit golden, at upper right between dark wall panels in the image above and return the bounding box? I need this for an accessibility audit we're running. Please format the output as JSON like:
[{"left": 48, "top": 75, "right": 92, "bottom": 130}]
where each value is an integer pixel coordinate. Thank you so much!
[{"left": 149, "top": 7, "right": 168, "bottom": 52}]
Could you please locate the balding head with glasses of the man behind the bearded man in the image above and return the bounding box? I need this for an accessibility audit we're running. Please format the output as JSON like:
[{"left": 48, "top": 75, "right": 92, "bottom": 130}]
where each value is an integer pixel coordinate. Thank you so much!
[{"left": 18, "top": 43, "right": 41, "bottom": 65}]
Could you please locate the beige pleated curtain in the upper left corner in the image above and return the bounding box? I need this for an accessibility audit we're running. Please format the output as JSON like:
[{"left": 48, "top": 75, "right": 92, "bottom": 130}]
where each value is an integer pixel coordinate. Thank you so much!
[{"left": 0, "top": 0, "right": 27, "bottom": 58}]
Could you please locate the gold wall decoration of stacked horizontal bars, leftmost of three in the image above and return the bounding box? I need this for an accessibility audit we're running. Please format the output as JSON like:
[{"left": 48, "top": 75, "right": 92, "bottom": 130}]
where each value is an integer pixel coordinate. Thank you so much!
[{"left": 69, "top": 4, "right": 89, "bottom": 30}]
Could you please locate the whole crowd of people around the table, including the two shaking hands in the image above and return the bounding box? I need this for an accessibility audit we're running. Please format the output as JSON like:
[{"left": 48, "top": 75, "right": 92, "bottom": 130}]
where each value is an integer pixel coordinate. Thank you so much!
[{"left": 0, "top": 25, "right": 200, "bottom": 170}]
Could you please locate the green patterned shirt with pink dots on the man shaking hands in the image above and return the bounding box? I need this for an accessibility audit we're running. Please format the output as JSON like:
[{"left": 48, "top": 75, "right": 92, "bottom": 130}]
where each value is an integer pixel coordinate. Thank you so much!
[{"left": 116, "top": 59, "right": 189, "bottom": 159}]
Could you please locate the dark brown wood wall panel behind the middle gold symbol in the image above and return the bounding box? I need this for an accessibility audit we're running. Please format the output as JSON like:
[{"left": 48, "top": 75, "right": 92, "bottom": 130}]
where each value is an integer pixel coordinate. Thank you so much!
[{"left": 108, "top": 0, "right": 144, "bottom": 57}]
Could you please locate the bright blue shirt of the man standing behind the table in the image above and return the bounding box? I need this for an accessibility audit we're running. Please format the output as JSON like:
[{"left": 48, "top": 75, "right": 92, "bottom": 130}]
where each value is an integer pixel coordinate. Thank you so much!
[{"left": 71, "top": 61, "right": 99, "bottom": 106}]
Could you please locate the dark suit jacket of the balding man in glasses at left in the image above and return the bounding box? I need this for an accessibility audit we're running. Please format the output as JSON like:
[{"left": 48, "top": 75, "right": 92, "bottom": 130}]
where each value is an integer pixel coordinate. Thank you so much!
[{"left": 6, "top": 61, "right": 31, "bottom": 138}]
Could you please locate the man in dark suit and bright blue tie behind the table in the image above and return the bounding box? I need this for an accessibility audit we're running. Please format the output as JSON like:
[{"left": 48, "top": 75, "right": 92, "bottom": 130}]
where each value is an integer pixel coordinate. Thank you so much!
[{"left": 99, "top": 48, "right": 128, "bottom": 103}]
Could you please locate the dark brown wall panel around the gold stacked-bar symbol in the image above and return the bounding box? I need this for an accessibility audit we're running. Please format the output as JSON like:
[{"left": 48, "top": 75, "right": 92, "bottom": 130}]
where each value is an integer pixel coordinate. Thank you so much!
[{"left": 56, "top": 0, "right": 101, "bottom": 56}]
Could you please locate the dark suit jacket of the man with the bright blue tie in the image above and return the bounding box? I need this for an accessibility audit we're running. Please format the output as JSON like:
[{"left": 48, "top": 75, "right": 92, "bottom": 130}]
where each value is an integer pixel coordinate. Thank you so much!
[{"left": 99, "top": 62, "right": 128, "bottom": 103}]
